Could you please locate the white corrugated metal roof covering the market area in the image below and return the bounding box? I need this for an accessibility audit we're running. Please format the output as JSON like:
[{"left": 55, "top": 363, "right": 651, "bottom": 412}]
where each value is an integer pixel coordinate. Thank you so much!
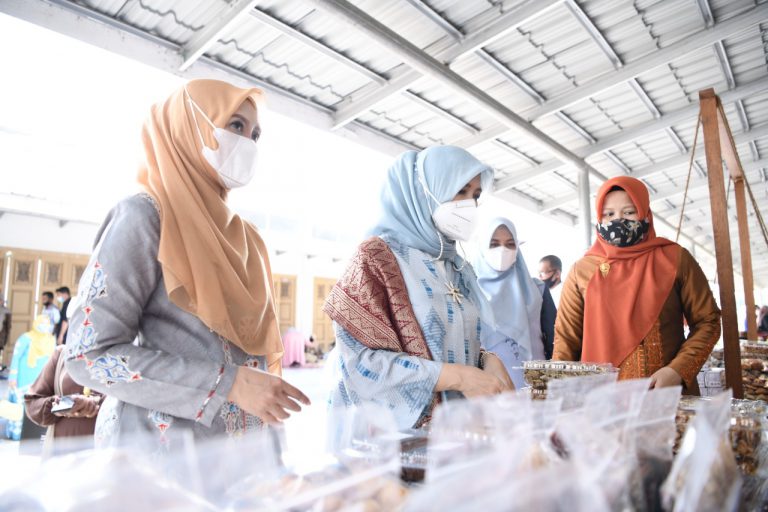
[{"left": 7, "top": 0, "right": 768, "bottom": 284}]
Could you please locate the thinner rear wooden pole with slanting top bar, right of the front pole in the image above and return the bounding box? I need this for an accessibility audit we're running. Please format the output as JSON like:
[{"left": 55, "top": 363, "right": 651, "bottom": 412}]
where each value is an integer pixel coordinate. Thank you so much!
[{"left": 717, "top": 98, "right": 757, "bottom": 340}]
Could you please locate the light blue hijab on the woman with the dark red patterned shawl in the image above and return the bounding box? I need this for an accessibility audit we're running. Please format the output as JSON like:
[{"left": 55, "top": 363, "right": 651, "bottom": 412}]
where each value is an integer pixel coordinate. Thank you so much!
[{"left": 370, "top": 146, "right": 493, "bottom": 266}]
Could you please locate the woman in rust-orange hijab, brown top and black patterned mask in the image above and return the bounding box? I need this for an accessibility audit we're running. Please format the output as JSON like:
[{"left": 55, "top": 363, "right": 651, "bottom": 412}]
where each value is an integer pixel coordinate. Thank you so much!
[{"left": 554, "top": 176, "right": 720, "bottom": 394}]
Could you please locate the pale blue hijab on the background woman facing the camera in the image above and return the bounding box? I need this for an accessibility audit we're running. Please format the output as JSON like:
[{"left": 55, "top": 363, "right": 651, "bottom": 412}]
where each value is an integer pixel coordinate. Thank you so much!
[{"left": 475, "top": 217, "right": 544, "bottom": 359}]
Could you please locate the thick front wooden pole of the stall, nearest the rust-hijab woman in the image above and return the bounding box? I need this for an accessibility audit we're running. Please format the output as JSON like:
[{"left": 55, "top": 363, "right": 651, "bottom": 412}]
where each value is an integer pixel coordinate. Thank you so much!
[{"left": 699, "top": 89, "right": 744, "bottom": 398}]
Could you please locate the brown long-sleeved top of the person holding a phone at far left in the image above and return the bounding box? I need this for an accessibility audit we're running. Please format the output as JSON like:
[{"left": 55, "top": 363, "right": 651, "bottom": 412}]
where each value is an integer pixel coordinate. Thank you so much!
[{"left": 24, "top": 345, "right": 102, "bottom": 438}]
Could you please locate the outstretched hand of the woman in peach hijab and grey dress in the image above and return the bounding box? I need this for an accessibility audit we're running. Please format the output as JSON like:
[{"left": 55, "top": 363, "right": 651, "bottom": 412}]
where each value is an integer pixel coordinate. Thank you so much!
[{"left": 227, "top": 366, "right": 310, "bottom": 423}]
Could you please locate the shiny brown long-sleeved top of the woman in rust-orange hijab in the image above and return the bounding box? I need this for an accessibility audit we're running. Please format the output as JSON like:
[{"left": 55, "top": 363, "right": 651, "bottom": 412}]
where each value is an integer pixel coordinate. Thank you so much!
[{"left": 553, "top": 248, "right": 720, "bottom": 394}]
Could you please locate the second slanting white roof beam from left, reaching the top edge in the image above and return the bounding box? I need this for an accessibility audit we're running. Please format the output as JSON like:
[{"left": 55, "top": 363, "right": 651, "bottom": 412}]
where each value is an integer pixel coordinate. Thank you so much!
[{"left": 334, "top": 0, "right": 564, "bottom": 127}]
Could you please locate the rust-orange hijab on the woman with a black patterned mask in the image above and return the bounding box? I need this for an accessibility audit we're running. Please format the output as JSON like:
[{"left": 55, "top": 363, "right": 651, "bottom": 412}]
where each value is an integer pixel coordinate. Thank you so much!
[{"left": 581, "top": 176, "right": 680, "bottom": 367}]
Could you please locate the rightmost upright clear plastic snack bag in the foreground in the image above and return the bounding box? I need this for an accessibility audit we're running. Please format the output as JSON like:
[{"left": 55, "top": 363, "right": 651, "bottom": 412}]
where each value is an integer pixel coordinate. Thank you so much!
[{"left": 662, "top": 391, "right": 741, "bottom": 512}]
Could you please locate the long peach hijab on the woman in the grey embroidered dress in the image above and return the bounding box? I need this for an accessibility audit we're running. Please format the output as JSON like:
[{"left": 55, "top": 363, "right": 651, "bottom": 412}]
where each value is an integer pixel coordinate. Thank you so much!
[{"left": 138, "top": 80, "right": 283, "bottom": 373}]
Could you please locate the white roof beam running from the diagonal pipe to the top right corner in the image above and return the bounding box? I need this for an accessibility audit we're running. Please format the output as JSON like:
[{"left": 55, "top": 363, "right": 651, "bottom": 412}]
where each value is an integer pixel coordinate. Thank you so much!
[{"left": 525, "top": 3, "right": 768, "bottom": 120}]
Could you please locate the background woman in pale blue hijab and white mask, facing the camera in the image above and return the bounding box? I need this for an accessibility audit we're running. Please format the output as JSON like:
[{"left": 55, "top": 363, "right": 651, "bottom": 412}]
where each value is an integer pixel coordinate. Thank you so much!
[{"left": 473, "top": 217, "right": 557, "bottom": 388}]
